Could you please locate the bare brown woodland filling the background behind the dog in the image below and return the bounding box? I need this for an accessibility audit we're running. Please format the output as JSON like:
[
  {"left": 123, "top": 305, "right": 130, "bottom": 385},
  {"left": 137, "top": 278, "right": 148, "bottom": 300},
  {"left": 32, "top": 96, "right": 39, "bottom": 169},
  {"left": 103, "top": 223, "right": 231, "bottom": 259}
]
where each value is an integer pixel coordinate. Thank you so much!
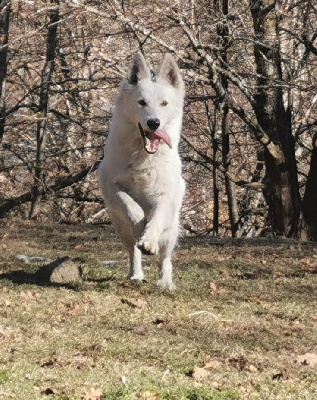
[{"left": 0, "top": 0, "right": 317, "bottom": 240}]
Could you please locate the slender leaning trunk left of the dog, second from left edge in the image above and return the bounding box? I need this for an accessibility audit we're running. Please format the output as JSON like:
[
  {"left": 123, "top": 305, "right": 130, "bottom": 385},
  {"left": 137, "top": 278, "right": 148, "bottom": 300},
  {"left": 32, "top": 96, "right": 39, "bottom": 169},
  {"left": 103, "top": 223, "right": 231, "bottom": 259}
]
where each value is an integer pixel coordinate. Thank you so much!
[{"left": 29, "top": 0, "right": 59, "bottom": 219}]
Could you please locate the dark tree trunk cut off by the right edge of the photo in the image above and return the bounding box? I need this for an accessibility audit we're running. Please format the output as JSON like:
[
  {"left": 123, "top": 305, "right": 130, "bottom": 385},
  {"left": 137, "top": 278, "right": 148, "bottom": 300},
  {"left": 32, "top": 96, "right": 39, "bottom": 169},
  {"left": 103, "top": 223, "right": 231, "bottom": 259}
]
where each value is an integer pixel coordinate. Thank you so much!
[{"left": 301, "top": 133, "right": 317, "bottom": 240}]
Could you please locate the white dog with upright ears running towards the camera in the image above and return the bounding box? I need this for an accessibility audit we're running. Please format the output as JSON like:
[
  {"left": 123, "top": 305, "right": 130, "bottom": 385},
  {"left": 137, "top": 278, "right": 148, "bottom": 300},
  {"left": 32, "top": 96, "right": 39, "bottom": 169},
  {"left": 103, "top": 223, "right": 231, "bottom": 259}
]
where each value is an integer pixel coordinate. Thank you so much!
[{"left": 99, "top": 53, "right": 185, "bottom": 289}]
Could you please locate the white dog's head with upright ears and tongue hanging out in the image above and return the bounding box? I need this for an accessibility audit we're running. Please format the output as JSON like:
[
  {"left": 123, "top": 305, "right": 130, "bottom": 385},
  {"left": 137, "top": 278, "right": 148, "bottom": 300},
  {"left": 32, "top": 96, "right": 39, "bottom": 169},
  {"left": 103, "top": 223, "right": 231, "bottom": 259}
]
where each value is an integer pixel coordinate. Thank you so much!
[{"left": 122, "top": 53, "right": 184, "bottom": 154}]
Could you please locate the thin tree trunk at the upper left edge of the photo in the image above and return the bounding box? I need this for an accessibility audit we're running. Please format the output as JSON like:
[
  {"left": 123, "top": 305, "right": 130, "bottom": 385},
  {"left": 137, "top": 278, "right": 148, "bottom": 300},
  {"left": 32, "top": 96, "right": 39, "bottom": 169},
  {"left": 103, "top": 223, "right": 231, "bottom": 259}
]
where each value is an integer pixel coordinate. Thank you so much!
[{"left": 0, "top": 0, "right": 11, "bottom": 144}]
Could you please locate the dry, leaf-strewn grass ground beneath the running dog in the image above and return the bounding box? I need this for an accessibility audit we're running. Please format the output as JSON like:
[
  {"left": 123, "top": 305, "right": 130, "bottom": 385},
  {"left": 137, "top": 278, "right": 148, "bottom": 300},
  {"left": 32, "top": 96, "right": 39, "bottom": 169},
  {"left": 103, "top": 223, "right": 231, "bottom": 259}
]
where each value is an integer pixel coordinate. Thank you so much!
[{"left": 0, "top": 220, "right": 317, "bottom": 400}]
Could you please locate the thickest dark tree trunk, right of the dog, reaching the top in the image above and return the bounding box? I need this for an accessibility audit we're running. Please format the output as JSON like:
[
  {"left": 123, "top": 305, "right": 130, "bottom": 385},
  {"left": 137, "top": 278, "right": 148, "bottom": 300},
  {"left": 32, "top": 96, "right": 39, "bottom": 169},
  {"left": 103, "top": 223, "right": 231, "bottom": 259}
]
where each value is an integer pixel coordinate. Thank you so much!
[{"left": 250, "top": 0, "right": 300, "bottom": 237}]
